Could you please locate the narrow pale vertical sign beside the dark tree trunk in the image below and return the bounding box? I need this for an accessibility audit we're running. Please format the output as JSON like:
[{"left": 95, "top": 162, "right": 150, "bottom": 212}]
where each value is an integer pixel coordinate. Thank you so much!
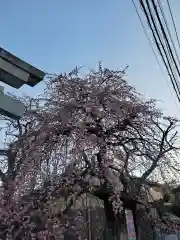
[{"left": 125, "top": 209, "right": 136, "bottom": 240}]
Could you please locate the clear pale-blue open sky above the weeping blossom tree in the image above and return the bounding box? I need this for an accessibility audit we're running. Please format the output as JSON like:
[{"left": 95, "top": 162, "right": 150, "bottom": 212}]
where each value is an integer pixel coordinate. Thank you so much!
[{"left": 0, "top": 0, "right": 180, "bottom": 117}]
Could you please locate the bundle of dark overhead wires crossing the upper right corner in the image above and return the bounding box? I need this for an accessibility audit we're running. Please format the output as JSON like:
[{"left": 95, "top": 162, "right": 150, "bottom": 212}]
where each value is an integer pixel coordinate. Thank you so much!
[{"left": 132, "top": 0, "right": 180, "bottom": 102}]
